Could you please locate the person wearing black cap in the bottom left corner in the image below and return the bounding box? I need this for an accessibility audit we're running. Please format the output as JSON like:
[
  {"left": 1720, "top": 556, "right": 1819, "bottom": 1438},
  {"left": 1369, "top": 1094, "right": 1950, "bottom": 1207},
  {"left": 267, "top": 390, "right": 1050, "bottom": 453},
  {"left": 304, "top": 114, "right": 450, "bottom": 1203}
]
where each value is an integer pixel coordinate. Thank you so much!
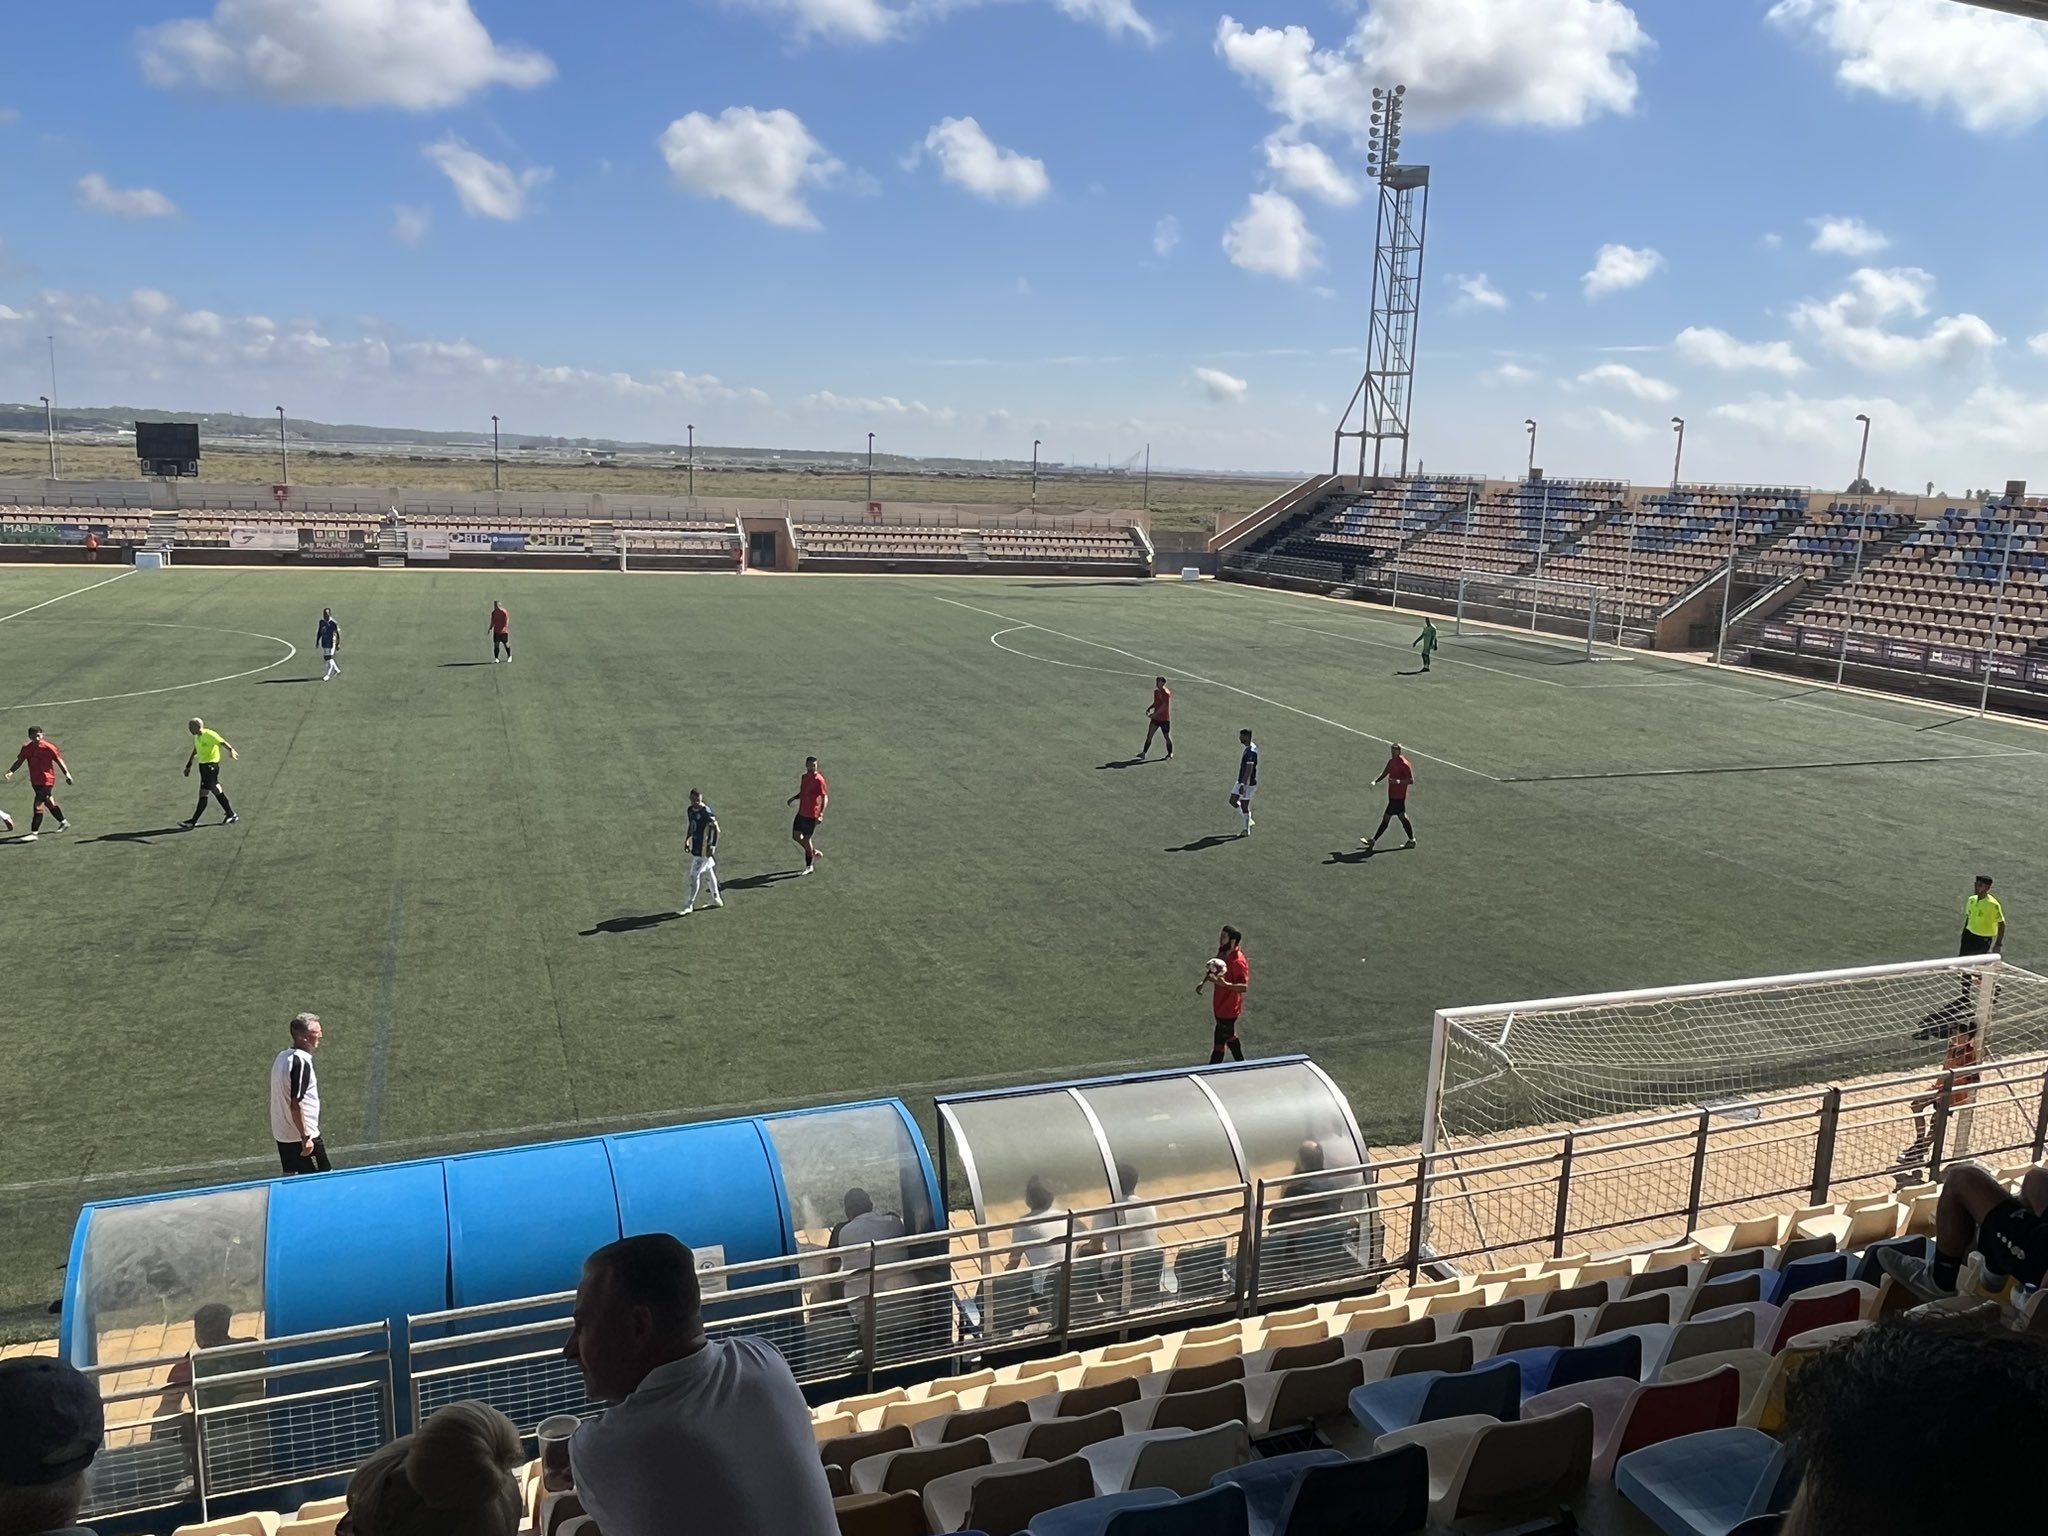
[{"left": 0, "top": 1356, "right": 106, "bottom": 1536}]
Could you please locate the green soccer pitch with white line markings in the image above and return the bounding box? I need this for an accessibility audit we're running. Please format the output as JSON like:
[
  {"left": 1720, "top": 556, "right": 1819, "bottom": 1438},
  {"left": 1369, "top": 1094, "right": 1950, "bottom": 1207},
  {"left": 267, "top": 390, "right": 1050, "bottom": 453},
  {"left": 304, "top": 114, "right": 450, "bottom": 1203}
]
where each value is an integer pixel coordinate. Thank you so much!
[{"left": 0, "top": 567, "right": 2048, "bottom": 1311}]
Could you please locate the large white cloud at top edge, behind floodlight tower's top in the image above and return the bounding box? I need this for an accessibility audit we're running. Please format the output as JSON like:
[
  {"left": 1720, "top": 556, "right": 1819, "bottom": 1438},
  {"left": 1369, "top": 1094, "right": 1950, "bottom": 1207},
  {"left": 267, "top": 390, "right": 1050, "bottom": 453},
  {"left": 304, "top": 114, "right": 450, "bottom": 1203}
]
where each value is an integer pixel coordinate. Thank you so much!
[{"left": 1217, "top": 0, "right": 1651, "bottom": 141}]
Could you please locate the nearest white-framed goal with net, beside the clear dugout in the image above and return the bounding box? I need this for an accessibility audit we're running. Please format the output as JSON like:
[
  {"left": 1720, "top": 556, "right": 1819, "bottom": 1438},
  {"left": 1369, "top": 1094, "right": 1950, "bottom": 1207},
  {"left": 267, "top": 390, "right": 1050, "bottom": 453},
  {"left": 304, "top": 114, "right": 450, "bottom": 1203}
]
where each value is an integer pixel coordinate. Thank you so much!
[{"left": 1417, "top": 954, "right": 2048, "bottom": 1257}]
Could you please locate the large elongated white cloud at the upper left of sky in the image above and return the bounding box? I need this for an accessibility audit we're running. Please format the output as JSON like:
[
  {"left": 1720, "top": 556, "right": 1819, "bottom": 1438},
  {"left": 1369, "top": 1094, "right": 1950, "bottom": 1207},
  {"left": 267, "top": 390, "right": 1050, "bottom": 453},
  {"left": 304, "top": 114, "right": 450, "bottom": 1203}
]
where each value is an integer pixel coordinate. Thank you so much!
[{"left": 135, "top": 0, "right": 555, "bottom": 113}]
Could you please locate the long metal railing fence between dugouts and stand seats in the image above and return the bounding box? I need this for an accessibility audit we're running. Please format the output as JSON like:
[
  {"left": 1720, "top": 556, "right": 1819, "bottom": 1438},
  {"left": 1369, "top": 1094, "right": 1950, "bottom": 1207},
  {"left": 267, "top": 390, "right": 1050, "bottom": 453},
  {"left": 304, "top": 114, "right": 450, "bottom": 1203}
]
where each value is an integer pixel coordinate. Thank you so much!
[{"left": 86, "top": 1053, "right": 2048, "bottom": 1518}]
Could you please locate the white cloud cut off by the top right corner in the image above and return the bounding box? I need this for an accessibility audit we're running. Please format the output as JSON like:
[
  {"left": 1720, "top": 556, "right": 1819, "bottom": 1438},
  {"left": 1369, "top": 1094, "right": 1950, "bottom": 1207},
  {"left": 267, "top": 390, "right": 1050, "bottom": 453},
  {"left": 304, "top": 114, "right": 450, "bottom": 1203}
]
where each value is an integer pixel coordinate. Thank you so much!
[{"left": 1769, "top": 0, "right": 2048, "bottom": 133}]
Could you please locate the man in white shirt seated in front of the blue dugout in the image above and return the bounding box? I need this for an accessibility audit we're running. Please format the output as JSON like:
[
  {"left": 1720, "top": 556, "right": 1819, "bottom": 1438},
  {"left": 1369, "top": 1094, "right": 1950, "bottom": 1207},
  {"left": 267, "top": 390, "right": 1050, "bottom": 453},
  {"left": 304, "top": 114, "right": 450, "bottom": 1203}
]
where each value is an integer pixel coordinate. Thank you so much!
[{"left": 563, "top": 1233, "right": 838, "bottom": 1536}]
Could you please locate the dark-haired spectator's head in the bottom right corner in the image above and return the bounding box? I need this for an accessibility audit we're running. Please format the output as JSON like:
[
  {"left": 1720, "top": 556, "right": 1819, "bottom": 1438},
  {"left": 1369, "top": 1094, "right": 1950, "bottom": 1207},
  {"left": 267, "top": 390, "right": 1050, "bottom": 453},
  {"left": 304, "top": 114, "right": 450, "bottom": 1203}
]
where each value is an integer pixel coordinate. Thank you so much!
[{"left": 1780, "top": 1315, "right": 2048, "bottom": 1536}]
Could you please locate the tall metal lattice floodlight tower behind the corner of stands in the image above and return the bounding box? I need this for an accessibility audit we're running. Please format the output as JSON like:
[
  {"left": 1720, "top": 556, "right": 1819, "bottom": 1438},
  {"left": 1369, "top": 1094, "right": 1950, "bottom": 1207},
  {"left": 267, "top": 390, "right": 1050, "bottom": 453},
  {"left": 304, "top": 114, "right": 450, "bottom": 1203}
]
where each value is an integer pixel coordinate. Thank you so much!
[{"left": 1329, "top": 86, "right": 1430, "bottom": 475}]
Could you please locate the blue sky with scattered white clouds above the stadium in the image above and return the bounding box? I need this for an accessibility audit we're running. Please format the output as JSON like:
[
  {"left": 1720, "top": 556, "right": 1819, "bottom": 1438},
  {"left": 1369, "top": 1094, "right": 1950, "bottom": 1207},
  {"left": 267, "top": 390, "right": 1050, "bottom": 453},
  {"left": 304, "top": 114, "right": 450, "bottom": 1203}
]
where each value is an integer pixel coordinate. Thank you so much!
[{"left": 0, "top": 0, "right": 2048, "bottom": 492}]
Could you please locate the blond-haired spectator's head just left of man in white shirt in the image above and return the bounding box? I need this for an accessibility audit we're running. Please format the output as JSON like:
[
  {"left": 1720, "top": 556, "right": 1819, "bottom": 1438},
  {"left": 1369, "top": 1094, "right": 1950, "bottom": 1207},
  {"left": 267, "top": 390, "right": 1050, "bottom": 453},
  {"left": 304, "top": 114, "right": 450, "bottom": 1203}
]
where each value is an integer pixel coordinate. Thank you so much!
[{"left": 336, "top": 1403, "right": 526, "bottom": 1536}]
